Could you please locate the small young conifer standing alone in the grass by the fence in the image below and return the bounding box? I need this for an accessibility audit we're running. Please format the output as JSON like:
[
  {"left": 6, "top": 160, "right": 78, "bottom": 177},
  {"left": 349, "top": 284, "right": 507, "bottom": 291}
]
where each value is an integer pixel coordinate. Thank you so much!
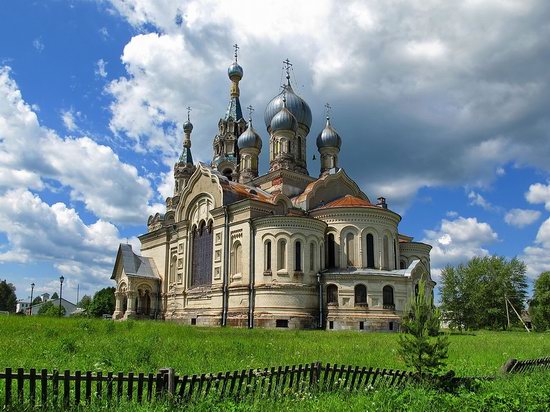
[{"left": 398, "top": 281, "right": 449, "bottom": 373}]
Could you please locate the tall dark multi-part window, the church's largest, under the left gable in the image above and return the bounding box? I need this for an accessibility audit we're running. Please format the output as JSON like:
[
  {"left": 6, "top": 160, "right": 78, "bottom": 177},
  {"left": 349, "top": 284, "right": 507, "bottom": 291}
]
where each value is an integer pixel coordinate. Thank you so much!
[{"left": 191, "top": 221, "right": 213, "bottom": 287}]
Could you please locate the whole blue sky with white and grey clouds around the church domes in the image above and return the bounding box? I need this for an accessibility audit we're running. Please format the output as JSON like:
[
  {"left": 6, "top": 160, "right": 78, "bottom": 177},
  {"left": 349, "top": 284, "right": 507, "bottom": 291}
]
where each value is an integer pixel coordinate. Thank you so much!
[{"left": 0, "top": 0, "right": 550, "bottom": 300}]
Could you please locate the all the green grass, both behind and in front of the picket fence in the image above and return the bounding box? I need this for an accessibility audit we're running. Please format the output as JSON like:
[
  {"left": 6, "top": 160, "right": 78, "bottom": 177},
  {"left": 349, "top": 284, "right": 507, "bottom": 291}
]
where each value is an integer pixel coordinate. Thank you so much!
[{"left": 0, "top": 317, "right": 550, "bottom": 411}]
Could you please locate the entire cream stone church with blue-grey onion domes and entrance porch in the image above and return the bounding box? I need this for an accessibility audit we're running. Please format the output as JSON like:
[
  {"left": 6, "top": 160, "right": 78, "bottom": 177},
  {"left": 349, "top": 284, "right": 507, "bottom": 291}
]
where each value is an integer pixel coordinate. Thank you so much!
[{"left": 112, "top": 50, "right": 435, "bottom": 331}]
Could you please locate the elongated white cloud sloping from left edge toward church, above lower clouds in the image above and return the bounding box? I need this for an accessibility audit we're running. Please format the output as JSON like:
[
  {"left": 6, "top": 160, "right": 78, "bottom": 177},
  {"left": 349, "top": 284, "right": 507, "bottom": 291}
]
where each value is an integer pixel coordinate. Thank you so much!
[{"left": 0, "top": 67, "right": 152, "bottom": 224}]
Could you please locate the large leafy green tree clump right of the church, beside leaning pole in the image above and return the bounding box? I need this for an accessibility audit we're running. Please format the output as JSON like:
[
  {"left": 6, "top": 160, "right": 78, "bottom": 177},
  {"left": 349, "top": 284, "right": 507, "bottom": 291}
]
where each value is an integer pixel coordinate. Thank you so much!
[{"left": 441, "top": 256, "right": 527, "bottom": 329}]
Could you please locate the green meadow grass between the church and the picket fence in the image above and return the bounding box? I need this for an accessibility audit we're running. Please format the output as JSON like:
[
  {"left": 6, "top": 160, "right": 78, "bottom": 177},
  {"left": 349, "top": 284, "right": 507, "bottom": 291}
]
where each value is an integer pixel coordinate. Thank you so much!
[{"left": 0, "top": 317, "right": 550, "bottom": 375}]
